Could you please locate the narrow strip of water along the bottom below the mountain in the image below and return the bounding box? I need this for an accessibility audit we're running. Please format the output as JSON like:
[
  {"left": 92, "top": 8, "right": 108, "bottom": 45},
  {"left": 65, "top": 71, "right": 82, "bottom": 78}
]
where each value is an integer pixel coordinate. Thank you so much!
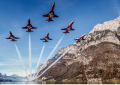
[{"left": 0, "top": 81, "right": 120, "bottom": 85}]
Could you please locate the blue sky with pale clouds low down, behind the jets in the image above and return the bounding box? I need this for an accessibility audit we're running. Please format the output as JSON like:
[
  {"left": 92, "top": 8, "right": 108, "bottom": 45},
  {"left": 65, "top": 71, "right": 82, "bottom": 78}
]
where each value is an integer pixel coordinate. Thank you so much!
[{"left": 0, "top": 0, "right": 120, "bottom": 76}]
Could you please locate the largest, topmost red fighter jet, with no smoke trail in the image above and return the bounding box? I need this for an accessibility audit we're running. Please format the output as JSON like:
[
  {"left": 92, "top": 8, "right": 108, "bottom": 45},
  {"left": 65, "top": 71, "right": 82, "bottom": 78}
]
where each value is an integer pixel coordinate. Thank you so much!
[{"left": 43, "top": 2, "right": 58, "bottom": 22}]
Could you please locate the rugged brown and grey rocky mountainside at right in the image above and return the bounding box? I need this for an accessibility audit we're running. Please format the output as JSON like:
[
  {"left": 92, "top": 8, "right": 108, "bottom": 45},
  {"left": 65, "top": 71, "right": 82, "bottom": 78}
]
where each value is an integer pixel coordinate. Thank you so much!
[{"left": 38, "top": 17, "right": 120, "bottom": 81}]
